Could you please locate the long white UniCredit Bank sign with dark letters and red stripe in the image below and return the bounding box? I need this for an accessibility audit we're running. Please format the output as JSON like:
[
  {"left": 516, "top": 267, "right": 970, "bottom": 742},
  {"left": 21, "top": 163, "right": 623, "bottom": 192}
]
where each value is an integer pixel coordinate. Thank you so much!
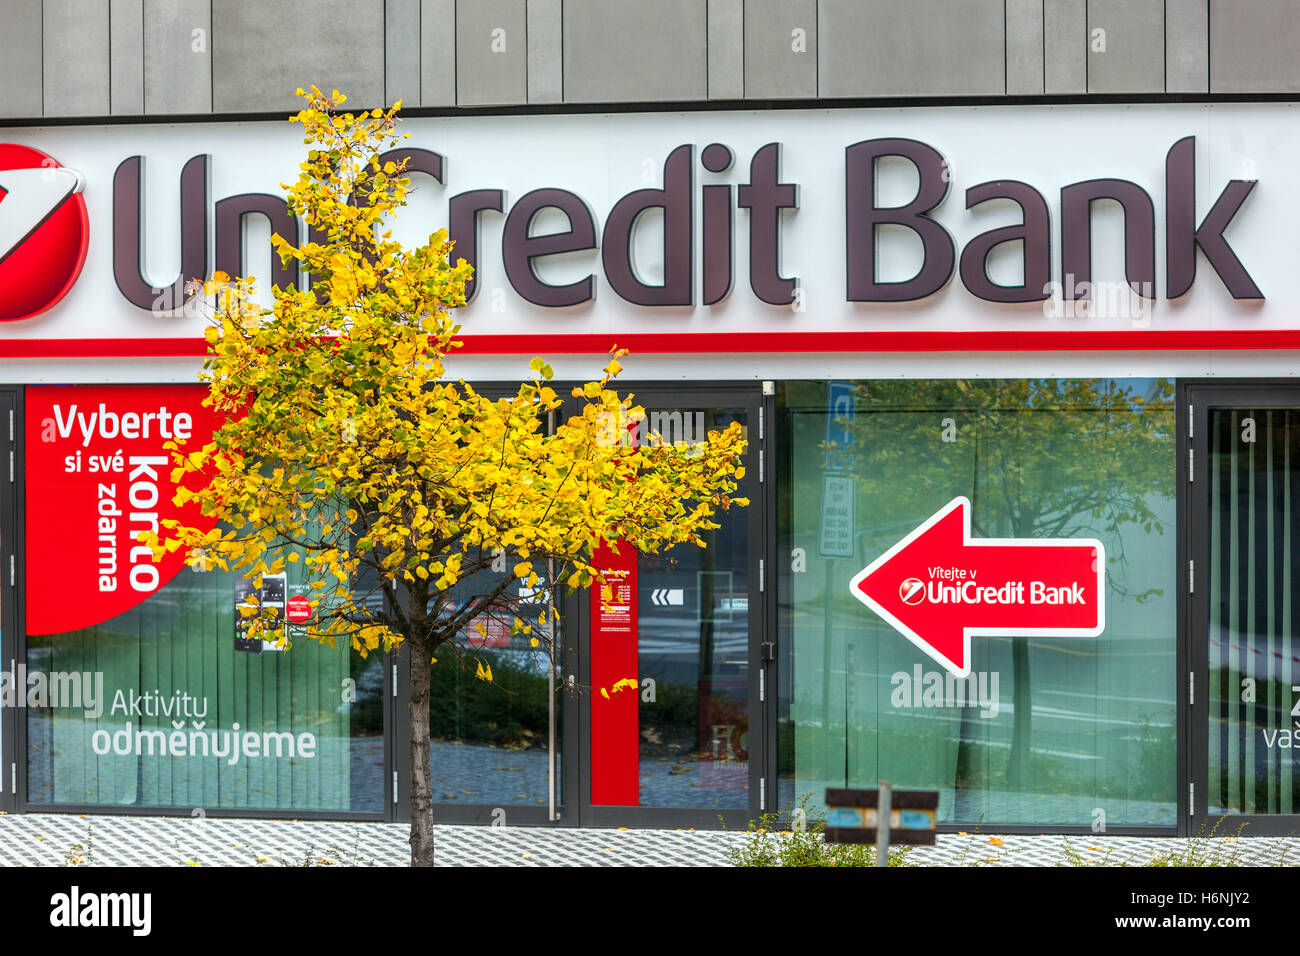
[{"left": 0, "top": 104, "right": 1300, "bottom": 356}]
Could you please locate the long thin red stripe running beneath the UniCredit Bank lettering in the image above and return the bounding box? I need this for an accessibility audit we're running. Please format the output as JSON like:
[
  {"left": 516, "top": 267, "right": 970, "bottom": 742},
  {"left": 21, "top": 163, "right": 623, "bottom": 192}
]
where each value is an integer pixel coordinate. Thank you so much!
[{"left": 0, "top": 329, "right": 1300, "bottom": 359}]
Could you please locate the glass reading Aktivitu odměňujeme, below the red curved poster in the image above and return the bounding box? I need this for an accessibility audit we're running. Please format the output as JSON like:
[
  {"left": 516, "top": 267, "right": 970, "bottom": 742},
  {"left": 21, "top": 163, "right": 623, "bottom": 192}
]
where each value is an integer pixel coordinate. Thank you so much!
[{"left": 26, "top": 563, "right": 384, "bottom": 813}]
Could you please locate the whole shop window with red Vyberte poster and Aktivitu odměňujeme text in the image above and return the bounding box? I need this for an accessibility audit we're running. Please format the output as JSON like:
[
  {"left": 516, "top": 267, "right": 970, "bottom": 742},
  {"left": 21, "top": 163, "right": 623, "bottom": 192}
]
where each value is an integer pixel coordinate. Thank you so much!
[{"left": 23, "top": 385, "right": 385, "bottom": 814}]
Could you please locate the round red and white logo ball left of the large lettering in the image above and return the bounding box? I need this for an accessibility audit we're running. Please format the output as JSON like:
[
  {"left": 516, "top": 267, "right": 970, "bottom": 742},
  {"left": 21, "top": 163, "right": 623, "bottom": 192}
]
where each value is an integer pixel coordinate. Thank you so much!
[{"left": 0, "top": 143, "right": 90, "bottom": 321}]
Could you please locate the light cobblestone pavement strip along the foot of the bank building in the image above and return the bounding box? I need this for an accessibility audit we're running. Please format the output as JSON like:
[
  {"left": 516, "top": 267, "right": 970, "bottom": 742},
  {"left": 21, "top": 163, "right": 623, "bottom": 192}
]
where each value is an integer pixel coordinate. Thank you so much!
[{"left": 0, "top": 814, "right": 1300, "bottom": 866}]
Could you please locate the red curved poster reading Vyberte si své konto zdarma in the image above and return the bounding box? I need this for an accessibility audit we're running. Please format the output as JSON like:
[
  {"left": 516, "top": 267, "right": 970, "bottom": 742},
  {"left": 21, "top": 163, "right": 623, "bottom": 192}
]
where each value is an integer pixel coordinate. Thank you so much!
[{"left": 23, "top": 385, "right": 215, "bottom": 635}]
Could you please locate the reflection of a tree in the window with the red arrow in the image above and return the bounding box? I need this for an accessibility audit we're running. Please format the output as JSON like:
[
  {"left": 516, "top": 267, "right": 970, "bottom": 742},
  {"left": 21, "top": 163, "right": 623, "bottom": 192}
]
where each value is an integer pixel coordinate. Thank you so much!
[{"left": 827, "top": 378, "right": 1174, "bottom": 791}]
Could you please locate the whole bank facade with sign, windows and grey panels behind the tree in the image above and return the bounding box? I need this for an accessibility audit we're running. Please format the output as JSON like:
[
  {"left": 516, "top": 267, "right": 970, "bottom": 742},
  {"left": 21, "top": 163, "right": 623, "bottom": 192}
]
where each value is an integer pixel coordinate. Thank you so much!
[{"left": 0, "top": 0, "right": 1300, "bottom": 834}]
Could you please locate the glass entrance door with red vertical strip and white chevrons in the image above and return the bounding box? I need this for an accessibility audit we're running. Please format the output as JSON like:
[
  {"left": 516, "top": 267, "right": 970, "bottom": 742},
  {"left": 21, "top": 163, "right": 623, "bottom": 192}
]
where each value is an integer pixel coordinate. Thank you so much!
[{"left": 580, "top": 384, "right": 767, "bottom": 826}]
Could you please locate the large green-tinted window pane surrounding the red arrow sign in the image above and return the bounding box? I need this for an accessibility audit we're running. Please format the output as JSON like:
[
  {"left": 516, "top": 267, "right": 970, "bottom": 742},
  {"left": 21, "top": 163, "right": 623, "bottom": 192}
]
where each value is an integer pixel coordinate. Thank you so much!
[{"left": 777, "top": 378, "right": 1177, "bottom": 826}]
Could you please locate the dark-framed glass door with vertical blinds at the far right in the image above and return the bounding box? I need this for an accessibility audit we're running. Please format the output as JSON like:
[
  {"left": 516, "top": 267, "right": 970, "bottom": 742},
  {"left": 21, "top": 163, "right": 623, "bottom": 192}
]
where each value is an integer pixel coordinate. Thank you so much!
[{"left": 1188, "top": 386, "right": 1300, "bottom": 836}]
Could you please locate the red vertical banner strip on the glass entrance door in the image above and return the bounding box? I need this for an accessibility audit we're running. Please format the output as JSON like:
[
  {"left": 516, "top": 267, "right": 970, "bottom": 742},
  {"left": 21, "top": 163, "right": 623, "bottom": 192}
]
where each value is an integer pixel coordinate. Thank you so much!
[{"left": 590, "top": 541, "right": 641, "bottom": 806}]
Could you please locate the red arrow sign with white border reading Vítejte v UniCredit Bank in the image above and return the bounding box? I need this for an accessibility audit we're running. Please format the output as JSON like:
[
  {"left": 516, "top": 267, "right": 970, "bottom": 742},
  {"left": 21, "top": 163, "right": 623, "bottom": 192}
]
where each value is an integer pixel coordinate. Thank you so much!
[{"left": 849, "top": 498, "right": 1106, "bottom": 678}]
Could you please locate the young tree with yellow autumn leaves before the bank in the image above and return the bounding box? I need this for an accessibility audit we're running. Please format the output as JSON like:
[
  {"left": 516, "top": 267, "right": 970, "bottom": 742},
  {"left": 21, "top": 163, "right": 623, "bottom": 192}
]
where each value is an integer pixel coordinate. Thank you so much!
[{"left": 142, "top": 87, "right": 748, "bottom": 865}]
